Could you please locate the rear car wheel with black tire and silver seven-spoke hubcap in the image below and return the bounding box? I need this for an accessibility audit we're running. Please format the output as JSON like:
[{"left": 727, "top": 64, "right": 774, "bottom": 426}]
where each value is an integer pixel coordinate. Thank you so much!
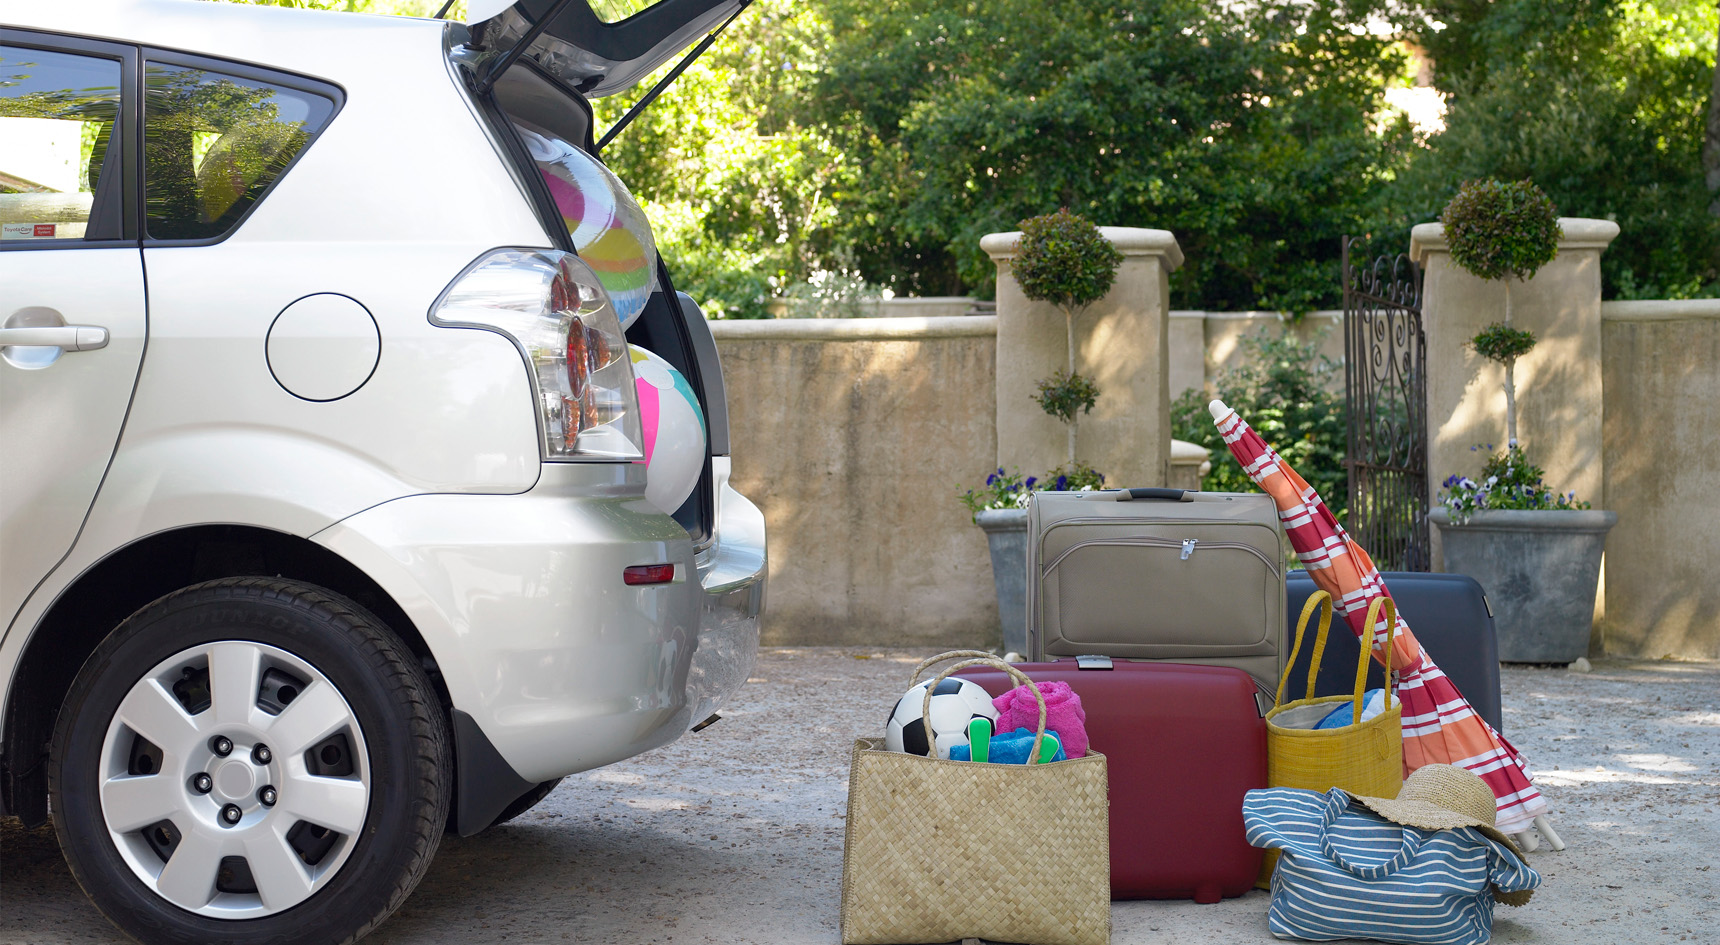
[{"left": 48, "top": 578, "right": 452, "bottom": 945}]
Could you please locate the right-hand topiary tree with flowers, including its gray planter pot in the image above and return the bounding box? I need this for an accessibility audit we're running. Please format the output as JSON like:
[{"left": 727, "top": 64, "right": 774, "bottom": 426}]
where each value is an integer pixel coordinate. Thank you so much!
[{"left": 1429, "top": 181, "right": 1617, "bottom": 663}]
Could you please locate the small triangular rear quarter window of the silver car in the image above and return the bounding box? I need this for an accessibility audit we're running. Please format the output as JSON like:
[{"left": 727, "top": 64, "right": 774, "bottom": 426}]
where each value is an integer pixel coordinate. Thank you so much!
[{"left": 143, "top": 62, "right": 334, "bottom": 239}]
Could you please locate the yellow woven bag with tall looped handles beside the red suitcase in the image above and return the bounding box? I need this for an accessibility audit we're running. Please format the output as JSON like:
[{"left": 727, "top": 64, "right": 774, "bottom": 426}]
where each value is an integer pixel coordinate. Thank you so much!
[{"left": 1256, "top": 590, "right": 1404, "bottom": 888}]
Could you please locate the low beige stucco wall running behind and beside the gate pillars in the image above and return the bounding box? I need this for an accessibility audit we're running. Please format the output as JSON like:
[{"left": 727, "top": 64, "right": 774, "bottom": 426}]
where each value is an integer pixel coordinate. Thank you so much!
[{"left": 712, "top": 284, "right": 1720, "bottom": 659}]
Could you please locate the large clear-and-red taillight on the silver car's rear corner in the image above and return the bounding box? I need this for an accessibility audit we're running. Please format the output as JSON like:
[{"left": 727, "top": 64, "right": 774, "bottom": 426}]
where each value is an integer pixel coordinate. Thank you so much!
[{"left": 430, "top": 250, "right": 645, "bottom": 460}]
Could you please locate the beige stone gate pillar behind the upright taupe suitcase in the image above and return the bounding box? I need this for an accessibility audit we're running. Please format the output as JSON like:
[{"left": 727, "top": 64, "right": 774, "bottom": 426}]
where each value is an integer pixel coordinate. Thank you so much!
[{"left": 980, "top": 227, "right": 1183, "bottom": 487}]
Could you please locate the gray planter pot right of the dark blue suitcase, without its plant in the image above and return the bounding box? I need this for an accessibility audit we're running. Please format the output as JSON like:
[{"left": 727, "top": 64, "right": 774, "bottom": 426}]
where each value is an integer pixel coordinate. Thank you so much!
[{"left": 1428, "top": 508, "right": 1619, "bottom": 663}]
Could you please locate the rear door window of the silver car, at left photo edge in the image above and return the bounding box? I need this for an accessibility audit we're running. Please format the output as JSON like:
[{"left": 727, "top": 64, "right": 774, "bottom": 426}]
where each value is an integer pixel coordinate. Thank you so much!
[{"left": 0, "top": 46, "right": 120, "bottom": 241}]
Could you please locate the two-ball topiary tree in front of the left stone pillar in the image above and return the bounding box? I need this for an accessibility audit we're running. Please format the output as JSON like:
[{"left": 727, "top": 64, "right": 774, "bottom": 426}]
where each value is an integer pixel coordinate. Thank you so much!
[{"left": 1011, "top": 207, "right": 1123, "bottom": 466}]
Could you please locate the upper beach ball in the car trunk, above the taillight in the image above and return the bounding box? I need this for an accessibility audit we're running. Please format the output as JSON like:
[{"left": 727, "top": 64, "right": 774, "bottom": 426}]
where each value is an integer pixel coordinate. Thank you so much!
[{"left": 514, "top": 122, "right": 657, "bottom": 329}]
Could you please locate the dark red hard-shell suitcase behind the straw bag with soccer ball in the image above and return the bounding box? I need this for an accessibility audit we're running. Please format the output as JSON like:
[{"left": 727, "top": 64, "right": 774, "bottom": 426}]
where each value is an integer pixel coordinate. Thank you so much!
[{"left": 958, "top": 656, "right": 1266, "bottom": 902}]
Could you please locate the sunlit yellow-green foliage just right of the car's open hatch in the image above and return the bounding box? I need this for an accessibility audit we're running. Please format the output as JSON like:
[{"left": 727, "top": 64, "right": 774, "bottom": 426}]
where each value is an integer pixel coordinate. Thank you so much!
[{"left": 593, "top": 0, "right": 835, "bottom": 317}]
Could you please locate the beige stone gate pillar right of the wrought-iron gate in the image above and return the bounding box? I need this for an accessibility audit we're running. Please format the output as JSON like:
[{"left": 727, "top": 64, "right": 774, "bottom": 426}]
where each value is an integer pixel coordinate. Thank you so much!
[{"left": 1410, "top": 217, "right": 1619, "bottom": 563}]
